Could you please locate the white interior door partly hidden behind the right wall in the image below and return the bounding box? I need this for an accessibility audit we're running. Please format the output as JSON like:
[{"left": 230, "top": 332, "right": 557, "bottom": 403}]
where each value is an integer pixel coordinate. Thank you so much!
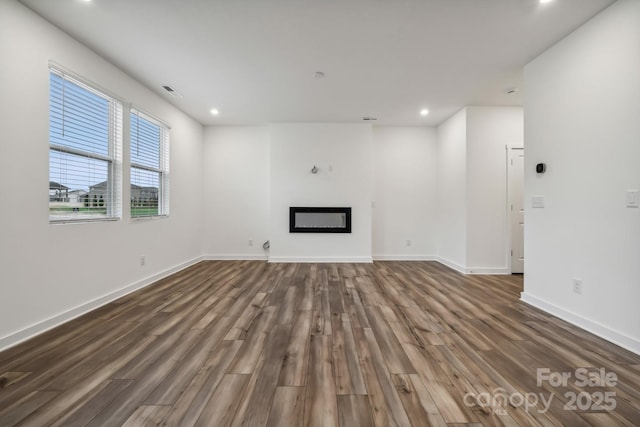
[{"left": 507, "top": 148, "right": 524, "bottom": 273}]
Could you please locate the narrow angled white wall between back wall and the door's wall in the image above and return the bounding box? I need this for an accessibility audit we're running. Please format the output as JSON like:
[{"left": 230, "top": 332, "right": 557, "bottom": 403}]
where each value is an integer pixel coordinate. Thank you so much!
[{"left": 437, "top": 108, "right": 467, "bottom": 271}]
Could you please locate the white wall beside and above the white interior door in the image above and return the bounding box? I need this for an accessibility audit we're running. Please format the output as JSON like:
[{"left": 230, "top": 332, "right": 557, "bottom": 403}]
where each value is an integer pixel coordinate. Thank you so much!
[{"left": 466, "top": 107, "right": 526, "bottom": 274}]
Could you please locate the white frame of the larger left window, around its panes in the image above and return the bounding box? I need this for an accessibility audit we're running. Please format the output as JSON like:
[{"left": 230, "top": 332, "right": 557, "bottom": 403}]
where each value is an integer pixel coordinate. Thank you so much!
[{"left": 48, "top": 66, "right": 124, "bottom": 224}]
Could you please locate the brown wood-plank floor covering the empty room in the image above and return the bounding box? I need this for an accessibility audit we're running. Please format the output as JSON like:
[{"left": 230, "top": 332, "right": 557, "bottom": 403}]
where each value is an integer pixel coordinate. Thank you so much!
[{"left": 0, "top": 261, "right": 640, "bottom": 427}]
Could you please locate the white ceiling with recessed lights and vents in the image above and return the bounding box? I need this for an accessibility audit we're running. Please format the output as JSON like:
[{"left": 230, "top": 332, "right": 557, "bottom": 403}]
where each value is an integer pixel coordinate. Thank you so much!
[{"left": 21, "top": 0, "right": 613, "bottom": 125}]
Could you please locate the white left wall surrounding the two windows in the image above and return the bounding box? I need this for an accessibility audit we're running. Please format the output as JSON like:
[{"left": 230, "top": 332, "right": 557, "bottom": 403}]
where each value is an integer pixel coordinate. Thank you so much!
[{"left": 0, "top": 1, "right": 203, "bottom": 348}]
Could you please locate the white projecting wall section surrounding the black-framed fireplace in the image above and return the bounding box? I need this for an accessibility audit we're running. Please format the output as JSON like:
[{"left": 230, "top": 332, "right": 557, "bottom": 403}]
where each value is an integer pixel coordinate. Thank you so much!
[{"left": 269, "top": 124, "right": 373, "bottom": 262}]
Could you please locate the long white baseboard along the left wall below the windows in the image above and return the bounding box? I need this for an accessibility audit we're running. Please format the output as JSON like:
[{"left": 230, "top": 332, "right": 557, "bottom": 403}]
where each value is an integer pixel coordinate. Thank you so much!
[{"left": 0, "top": 256, "right": 202, "bottom": 351}]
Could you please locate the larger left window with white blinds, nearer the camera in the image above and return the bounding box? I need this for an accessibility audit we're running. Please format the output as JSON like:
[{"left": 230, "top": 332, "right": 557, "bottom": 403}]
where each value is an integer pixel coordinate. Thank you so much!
[{"left": 49, "top": 68, "right": 122, "bottom": 222}]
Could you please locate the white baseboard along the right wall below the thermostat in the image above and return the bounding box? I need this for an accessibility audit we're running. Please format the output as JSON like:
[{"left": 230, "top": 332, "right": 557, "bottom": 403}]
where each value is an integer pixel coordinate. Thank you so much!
[{"left": 520, "top": 292, "right": 640, "bottom": 355}]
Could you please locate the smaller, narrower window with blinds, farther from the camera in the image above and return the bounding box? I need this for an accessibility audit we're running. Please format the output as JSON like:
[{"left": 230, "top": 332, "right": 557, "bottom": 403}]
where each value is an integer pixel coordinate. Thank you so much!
[{"left": 130, "top": 109, "right": 169, "bottom": 218}]
